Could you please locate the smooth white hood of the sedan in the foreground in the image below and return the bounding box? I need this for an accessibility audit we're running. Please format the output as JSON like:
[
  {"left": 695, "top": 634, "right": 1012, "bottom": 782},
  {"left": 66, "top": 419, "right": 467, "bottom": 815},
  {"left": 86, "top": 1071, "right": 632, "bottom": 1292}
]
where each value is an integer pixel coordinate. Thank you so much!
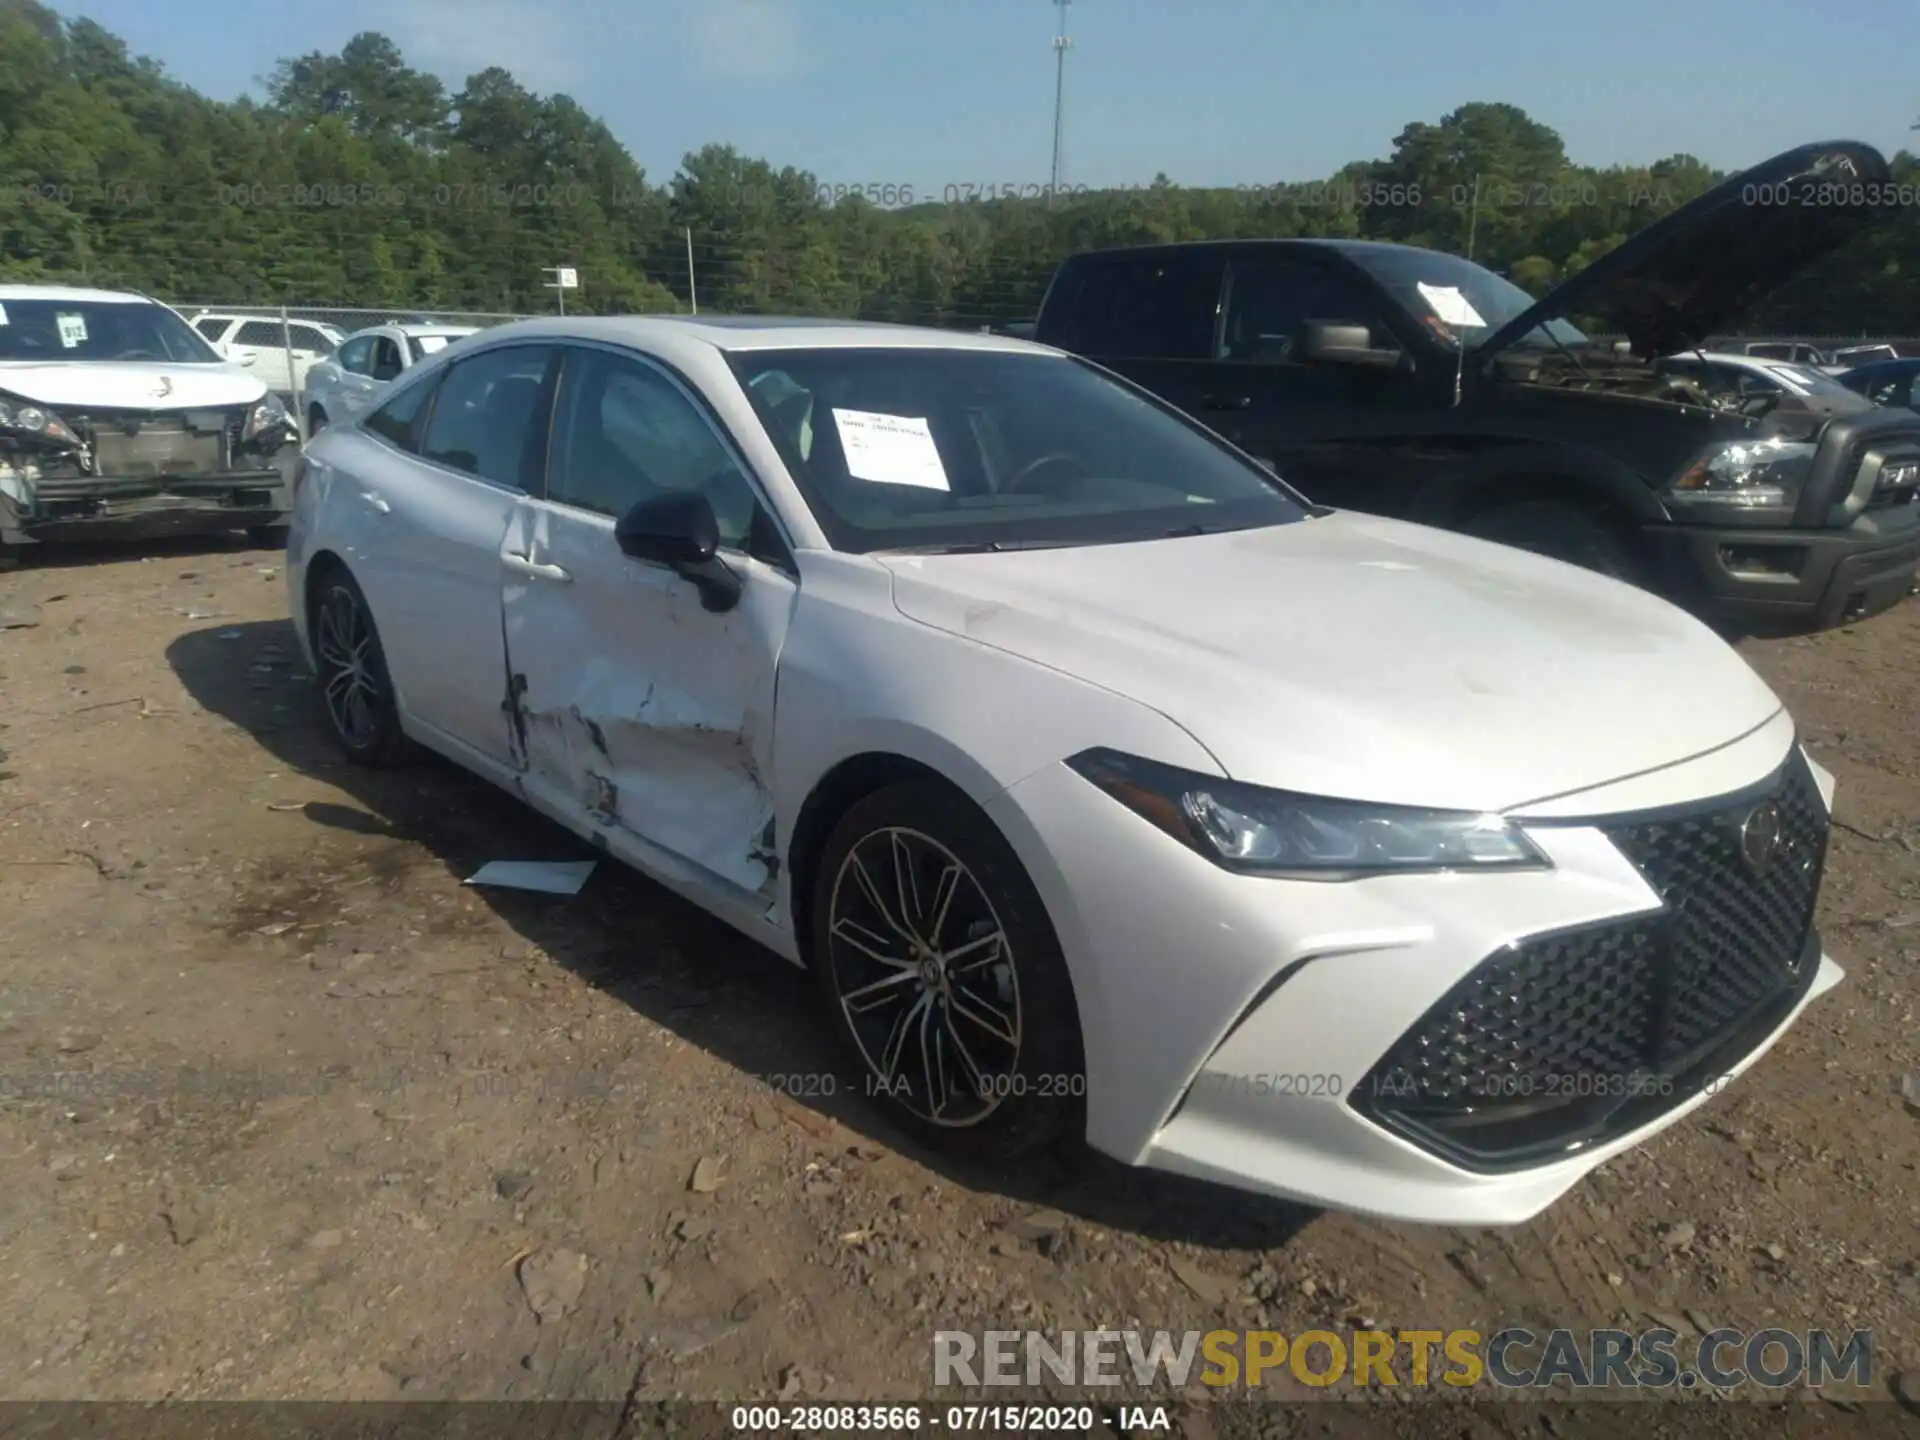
[{"left": 877, "top": 513, "right": 1780, "bottom": 810}]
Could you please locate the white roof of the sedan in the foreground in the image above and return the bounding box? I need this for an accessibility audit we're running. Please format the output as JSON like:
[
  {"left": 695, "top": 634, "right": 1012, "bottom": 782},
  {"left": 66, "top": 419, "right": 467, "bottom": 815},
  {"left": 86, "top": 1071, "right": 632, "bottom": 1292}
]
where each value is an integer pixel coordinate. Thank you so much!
[{"left": 458, "top": 315, "right": 1060, "bottom": 355}]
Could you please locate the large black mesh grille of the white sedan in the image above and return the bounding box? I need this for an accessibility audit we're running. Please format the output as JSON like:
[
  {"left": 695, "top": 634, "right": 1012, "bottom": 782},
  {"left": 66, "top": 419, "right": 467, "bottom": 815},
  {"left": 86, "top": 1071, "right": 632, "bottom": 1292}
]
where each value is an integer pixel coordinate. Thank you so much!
[{"left": 1356, "top": 751, "right": 1828, "bottom": 1167}]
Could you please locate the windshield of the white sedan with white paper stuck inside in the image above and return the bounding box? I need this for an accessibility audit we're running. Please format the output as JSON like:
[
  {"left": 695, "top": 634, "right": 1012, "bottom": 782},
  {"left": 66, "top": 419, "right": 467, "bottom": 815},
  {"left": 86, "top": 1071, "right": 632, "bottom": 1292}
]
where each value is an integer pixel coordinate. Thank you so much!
[{"left": 730, "top": 348, "right": 1308, "bottom": 553}]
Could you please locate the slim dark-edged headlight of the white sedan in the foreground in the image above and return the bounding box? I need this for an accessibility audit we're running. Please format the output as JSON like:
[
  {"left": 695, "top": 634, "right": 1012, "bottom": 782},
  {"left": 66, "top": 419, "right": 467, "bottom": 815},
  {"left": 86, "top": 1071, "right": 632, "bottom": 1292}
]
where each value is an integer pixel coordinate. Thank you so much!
[{"left": 1068, "top": 751, "right": 1551, "bottom": 879}]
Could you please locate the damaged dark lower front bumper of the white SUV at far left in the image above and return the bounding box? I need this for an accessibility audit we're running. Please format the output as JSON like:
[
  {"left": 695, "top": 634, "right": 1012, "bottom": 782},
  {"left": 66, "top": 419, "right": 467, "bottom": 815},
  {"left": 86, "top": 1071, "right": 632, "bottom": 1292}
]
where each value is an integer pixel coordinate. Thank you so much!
[{"left": 0, "top": 467, "right": 292, "bottom": 545}]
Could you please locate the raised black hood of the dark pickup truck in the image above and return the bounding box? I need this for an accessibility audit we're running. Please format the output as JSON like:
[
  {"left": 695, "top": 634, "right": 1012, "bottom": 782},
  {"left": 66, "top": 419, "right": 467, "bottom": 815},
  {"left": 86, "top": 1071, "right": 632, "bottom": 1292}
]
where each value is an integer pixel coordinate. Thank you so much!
[{"left": 1478, "top": 140, "right": 1889, "bottom": 357}]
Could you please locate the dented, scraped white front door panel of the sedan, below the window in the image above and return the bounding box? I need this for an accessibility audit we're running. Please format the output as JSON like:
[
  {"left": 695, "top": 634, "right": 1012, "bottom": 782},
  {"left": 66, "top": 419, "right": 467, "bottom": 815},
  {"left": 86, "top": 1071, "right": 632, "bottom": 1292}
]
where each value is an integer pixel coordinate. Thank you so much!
[{"left": 505, "top": 501, "right": 795, "bottom": 900}]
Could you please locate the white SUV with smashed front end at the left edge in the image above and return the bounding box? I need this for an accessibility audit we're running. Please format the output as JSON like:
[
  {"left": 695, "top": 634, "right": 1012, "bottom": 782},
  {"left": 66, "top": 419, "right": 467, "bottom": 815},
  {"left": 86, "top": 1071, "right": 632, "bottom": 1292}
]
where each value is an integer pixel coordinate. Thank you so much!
[{"left": 0, "top": 286, "right": 300, "bottom": 547}]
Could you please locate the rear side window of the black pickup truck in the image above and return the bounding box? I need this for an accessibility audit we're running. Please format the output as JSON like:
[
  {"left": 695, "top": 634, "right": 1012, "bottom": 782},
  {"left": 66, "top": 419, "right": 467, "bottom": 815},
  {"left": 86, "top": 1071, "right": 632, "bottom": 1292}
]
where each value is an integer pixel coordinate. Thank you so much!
[{"left": 1048, "top": 250, "right": 1225, "bottom": 359}]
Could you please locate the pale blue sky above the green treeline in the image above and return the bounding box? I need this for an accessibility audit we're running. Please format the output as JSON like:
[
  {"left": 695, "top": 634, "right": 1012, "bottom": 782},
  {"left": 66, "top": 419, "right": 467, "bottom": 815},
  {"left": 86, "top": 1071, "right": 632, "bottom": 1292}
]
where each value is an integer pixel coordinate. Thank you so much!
[{"left": 56, "top": 0, "right": 1920, "bottom": 192}]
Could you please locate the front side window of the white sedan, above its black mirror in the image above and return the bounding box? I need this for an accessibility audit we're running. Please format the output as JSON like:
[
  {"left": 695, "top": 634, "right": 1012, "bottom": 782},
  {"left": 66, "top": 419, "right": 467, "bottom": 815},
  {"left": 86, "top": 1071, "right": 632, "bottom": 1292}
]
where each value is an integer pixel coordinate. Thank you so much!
[{"left": 547, "top": 349, "right": 758, "bottom": 547}]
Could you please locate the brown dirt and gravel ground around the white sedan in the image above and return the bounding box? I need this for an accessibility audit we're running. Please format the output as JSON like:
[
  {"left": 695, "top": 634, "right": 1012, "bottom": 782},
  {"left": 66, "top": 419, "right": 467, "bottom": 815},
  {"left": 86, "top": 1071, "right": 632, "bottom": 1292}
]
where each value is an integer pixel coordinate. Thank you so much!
[{"left": 0, "top": 541, "right": 1920, "bottom": 1428}]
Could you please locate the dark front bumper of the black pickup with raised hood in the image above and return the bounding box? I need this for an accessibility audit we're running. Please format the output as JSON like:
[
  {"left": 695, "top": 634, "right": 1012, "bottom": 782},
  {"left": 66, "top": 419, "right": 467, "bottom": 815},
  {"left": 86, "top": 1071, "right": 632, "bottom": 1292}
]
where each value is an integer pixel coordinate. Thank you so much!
[{"left": 1645, "top": 507, "right": 1920, "bottom": 636}]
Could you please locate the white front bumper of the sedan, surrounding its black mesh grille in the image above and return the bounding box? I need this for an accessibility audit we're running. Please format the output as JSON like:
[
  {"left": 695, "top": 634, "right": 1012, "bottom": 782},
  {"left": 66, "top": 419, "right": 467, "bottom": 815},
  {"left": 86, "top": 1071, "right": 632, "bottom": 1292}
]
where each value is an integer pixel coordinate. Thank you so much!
[{"left": 987, "top": 716, "right": 1841, "bottom": 1225}]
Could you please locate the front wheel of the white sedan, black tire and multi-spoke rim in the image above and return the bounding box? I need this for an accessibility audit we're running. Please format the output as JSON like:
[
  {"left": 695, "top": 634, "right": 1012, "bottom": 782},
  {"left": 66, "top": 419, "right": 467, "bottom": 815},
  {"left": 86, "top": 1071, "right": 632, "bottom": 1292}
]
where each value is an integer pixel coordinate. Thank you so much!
[{"left": 808, "top": 781, "right": 1087, "bottom": 1160}]
